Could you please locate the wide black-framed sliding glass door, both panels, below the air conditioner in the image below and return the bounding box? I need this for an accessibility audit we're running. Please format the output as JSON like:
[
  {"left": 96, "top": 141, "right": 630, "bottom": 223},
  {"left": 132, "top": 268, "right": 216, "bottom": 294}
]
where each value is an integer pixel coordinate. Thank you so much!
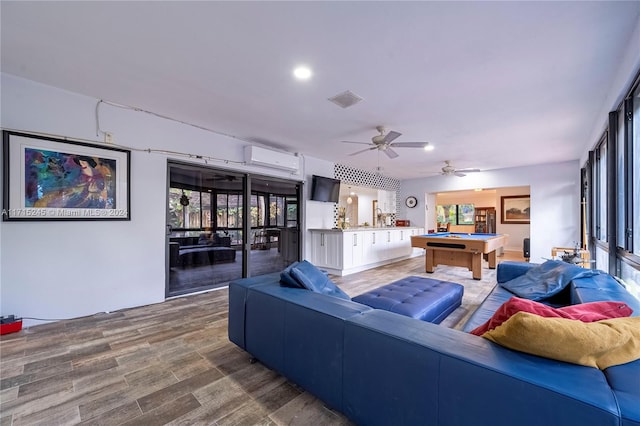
[{"left": 166, "top": 162, "right": 301, "bottom": 297}]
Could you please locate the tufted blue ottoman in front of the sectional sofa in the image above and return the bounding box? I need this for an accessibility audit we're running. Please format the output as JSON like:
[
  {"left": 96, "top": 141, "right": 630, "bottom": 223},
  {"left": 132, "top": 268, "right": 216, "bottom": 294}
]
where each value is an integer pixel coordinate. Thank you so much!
[{"left": 351, "top": 276, "right": 464, "bottom": 324}]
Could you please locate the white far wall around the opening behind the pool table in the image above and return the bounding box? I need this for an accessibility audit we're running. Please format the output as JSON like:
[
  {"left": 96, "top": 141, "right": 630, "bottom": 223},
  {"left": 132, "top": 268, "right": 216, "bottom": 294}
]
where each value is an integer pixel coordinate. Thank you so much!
[{"left": 400, "top": 160, "right": 580, "bottom": 262}]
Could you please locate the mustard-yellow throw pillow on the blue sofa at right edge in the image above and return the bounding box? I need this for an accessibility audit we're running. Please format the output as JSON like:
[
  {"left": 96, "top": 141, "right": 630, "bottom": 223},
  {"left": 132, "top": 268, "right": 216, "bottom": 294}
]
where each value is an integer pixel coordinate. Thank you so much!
[{"left": 482, "top": 312, "right": 640, "bottom": 370}]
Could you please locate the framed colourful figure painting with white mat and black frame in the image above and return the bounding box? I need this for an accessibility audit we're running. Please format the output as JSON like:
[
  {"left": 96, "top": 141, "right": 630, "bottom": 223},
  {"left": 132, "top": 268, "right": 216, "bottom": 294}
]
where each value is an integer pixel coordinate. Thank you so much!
[{"left": 2, "top": 130, "right": 131, "bottom": 221}]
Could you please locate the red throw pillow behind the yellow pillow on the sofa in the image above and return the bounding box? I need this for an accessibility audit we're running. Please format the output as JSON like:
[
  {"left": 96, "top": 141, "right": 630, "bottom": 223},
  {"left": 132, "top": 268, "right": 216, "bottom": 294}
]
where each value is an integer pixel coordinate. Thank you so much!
[{"left": 470, "top": 297, "right": 633, "bottom": 336}]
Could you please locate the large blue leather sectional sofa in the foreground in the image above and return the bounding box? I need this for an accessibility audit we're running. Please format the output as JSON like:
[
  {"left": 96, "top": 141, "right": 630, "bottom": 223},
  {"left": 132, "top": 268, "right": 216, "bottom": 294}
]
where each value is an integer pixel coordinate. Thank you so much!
[{"left": 229, "top": 262, "right": 640, "bottom": 426}]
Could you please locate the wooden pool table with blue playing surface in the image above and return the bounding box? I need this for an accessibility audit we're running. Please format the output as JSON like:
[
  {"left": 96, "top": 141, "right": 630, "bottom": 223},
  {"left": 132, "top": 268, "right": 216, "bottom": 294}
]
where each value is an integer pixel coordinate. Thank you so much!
[{"left": 411, "top": 232, "right": 507, "bottom": 280}]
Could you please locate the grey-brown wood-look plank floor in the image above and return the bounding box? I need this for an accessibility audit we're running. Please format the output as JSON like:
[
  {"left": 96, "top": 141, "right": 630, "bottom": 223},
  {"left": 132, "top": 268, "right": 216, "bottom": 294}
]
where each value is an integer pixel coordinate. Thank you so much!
[{"left": 0, "top": 253, "right": 521, "bottom": 426}]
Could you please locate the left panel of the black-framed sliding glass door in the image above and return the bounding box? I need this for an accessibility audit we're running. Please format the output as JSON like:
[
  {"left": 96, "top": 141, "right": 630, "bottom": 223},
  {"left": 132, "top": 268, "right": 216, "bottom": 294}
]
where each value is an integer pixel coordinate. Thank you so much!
[{"left": 166, "top": 163, "right": 245, "bottom": 297}]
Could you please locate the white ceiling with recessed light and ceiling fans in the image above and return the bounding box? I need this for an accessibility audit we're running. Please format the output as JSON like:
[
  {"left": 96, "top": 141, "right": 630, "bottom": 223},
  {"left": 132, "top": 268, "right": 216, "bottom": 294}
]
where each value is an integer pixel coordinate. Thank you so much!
[{"left": 0, "top": 0, "right": 640, "bottom": 179}]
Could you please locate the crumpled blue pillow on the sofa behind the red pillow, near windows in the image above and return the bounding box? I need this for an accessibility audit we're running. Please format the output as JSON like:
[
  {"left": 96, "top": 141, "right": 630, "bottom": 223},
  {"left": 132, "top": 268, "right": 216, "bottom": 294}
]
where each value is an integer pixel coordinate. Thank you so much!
[{"left": 500, "top": 260, "right": 600, "bottom": 300}]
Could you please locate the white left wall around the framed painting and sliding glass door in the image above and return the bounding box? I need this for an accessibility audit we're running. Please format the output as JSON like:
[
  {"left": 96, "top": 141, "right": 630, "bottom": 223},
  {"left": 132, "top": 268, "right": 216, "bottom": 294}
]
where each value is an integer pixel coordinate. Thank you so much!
[{"left": 0, "top": 74, "right": 320, "bottom": 326}]
